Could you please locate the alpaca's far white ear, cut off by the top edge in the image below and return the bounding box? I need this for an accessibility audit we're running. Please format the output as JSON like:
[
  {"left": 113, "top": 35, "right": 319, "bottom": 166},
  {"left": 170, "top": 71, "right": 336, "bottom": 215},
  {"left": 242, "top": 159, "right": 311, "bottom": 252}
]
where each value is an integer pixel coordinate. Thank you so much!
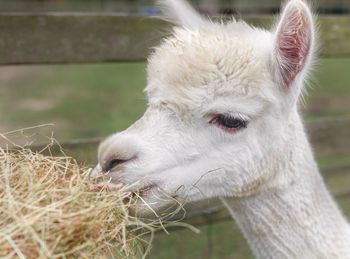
[{"left": 158, "top": 0, "right": 204, "bottom": 28}]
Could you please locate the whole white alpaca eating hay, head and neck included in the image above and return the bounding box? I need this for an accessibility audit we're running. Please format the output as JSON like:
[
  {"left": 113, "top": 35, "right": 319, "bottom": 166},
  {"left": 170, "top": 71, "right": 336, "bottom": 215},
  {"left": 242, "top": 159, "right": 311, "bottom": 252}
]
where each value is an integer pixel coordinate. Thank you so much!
[{"left": 93, "top": 0, "right": 350, "bottom": 258}]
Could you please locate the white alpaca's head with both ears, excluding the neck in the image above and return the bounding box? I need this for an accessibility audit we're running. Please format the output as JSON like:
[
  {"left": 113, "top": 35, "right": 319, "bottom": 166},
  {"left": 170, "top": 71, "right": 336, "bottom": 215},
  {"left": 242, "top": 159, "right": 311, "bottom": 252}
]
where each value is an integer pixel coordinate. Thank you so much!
[{"left": 93, "top": 0, "right": 314, "bottom": 215}]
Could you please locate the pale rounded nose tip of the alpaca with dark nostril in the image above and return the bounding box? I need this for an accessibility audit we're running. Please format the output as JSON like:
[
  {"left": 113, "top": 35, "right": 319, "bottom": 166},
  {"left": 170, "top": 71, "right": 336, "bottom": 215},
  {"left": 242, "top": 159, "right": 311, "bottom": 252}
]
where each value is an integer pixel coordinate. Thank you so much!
[{"left": 98, "top": 135, "right": 138, "bottom": 172}]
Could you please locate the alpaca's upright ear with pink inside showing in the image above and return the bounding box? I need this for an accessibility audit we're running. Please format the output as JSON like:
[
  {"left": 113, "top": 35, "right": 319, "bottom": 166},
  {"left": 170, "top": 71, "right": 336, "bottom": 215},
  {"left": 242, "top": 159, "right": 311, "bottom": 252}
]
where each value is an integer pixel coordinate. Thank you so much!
[{"left": 272, "top": 0, "right": 314, "bottom": 88}]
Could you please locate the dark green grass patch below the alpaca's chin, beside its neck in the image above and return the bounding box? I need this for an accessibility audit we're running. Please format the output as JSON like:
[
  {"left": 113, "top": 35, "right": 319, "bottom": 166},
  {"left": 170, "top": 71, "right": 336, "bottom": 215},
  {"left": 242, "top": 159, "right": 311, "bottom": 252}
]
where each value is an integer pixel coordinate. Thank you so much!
[{"left": 149, "top": 221, "right": 254, "bottom": 259}]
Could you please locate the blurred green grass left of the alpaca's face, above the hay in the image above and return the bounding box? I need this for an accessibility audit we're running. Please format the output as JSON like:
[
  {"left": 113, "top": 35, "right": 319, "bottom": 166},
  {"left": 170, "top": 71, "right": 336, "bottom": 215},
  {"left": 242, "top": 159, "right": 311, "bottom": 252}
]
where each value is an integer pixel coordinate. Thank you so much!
[{"left": 0, "top": 63, "right": 146, "bottom": 140}]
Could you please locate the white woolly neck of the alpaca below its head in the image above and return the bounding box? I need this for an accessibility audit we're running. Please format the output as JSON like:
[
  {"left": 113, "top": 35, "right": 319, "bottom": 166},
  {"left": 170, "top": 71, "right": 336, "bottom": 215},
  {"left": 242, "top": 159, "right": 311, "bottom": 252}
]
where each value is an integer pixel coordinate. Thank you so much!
[{"left": 223, "top": 114, "right": 350, "bottom": 258}]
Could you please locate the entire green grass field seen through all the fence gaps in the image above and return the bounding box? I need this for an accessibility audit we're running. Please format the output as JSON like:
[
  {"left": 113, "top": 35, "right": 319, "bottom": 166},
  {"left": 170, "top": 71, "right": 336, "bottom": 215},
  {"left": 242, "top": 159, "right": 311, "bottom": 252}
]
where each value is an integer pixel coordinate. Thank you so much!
[{"left": 0, "top": 59, "right": 350, "bottom": 259}]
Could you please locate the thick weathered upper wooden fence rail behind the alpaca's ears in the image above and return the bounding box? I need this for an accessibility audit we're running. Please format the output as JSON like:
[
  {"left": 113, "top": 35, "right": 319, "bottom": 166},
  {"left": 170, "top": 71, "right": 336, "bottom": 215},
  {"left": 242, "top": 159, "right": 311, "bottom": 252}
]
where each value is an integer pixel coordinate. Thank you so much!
[{"left": 0, "top": 13, "right": 350, "bottom": 65}]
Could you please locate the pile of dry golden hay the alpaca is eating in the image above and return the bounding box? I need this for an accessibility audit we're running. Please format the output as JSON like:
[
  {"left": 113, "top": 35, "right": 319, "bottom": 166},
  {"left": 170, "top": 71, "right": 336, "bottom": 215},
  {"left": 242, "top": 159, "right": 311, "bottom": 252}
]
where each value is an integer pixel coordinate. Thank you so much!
[{"left": 0, "top": 148, "right": 151, "bottom": 258}]
